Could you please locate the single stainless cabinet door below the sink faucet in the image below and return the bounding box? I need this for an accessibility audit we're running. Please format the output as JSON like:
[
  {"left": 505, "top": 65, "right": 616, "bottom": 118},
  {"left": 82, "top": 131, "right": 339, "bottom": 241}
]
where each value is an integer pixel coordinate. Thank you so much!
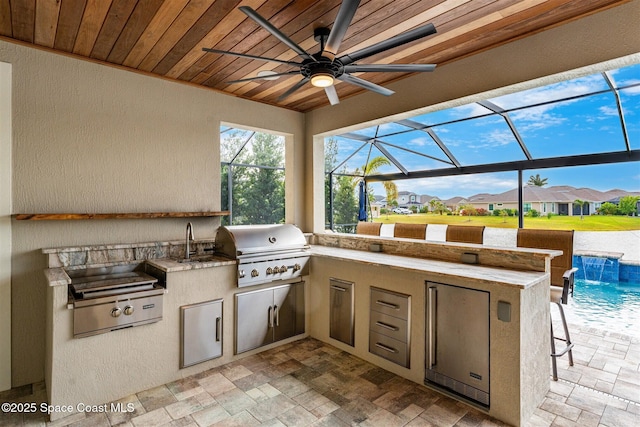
[{"left": 180, "top": 299, "right": 222, "bottom": 368}]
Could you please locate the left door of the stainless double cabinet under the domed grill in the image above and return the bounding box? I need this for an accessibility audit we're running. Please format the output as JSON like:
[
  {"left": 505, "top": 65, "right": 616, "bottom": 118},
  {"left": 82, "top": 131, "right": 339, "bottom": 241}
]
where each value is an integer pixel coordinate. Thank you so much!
[{"left": 236, "top": 289, "right": 273, "bottom": 354}]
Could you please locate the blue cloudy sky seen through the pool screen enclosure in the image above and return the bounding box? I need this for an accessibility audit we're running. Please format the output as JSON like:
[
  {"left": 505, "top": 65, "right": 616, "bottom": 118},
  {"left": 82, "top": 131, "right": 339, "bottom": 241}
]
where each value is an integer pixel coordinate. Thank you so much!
[{"left": 334, "top": 64, "right": 640, "bottom": 199}]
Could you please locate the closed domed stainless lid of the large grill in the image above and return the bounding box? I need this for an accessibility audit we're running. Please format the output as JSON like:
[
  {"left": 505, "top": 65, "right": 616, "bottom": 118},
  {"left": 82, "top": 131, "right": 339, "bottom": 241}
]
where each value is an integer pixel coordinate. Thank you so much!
[{"left": 216, "top": 224, "right": 308, "bottom": 259}]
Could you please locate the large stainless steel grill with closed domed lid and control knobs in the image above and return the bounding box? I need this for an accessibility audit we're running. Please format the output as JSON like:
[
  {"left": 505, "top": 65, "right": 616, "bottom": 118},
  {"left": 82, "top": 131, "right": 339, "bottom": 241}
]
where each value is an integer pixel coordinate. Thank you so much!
[{"left": 216, "top": 224, "right": 309, "bottom": 287}]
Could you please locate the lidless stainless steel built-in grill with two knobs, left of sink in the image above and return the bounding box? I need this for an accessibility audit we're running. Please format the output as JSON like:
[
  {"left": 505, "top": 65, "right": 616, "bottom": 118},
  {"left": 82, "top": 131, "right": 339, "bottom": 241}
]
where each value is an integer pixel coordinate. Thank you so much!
[{"left": 68, "top": 264, "right": 165, "bottom": 338}]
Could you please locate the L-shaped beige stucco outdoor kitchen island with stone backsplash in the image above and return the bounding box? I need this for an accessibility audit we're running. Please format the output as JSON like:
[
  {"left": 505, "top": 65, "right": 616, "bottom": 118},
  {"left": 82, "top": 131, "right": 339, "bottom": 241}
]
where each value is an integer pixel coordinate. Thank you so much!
[{"left": 45, "top": 234, "right": 557, "bottom": 425}]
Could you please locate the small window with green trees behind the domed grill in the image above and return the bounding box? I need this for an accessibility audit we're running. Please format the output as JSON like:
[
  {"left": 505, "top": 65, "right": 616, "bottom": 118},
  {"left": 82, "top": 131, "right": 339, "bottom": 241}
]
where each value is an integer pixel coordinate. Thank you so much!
[{"left": 220, "top": 126, "right": 285, "bottom": 225}]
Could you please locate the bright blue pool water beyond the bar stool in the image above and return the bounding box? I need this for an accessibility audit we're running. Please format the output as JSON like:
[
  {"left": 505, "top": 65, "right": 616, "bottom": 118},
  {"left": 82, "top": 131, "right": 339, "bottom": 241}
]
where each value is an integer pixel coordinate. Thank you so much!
[{"left": 554, "top": 279, "right": 640, "bottom": 337}]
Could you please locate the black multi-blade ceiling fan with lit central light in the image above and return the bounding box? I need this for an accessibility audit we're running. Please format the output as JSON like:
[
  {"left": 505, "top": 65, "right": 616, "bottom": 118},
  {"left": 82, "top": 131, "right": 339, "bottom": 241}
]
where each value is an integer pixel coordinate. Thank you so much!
[{"left": 202, "top": 0, "right": 436, "bottom": 105}]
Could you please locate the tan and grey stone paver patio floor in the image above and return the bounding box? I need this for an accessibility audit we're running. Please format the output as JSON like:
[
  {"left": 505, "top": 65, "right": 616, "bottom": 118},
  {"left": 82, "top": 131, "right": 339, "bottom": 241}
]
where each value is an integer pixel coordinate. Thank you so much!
[{"left": 0, "top": 326, "right": 640, "bottom": 427}]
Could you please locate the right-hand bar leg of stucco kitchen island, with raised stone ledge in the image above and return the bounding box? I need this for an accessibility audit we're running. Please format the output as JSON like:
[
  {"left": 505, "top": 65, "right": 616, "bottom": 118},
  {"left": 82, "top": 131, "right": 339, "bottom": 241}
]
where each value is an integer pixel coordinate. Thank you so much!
[{"left": 307, "top": 234, "right": 559, "bottom": 426}]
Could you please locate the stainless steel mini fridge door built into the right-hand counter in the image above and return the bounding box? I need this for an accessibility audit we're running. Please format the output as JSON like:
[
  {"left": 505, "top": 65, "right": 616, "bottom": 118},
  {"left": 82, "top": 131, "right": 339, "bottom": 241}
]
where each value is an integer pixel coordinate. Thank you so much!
[{"left": 425, "top": 282, "right": 489, "bottom": 407}]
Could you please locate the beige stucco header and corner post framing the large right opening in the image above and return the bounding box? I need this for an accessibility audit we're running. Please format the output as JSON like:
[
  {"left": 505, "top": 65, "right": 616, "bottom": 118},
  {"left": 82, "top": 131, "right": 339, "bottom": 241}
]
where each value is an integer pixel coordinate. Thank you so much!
[{"left": 305, "top": 0, "right": 640, "bottom": 232}]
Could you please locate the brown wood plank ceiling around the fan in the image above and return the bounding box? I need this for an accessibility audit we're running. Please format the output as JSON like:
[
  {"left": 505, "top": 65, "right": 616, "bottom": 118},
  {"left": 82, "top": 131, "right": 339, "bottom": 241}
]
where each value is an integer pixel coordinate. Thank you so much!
[{"left": 0, "top": 0, "right": 628, "bottom": 111}]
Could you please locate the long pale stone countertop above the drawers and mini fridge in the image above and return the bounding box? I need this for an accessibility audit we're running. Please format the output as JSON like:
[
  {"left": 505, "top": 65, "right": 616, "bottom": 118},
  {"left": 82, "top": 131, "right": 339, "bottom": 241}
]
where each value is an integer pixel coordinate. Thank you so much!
[{"left": 311, "top": 245, "right": 548, "bottom": 289}]
